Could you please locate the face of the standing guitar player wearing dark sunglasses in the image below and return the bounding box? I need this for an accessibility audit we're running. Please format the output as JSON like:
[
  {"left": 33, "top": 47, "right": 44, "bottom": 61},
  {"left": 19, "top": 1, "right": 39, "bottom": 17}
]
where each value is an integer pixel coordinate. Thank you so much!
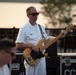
[{"left": 28, "top": 8, "right": 39, "bottom": 22}]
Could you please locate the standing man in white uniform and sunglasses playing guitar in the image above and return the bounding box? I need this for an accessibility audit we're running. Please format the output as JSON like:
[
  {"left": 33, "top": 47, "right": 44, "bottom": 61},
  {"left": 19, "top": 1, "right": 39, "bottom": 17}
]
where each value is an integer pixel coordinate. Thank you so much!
[{"left": 16, "top": 6, "right": 67, "bottom": 75}]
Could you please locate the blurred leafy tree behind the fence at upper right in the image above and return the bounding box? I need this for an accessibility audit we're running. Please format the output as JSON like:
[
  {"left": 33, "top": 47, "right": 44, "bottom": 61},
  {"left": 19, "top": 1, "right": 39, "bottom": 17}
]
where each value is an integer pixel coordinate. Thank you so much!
[{"left": 40, "top": 0, "right": 76, "bottom": 27}]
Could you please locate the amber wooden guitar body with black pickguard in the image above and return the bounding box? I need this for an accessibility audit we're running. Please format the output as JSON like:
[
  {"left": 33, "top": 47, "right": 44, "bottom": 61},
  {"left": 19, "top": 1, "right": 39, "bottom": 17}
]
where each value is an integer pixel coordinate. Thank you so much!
[{"left": 23, "top": 39, "right": 47, "bottom": 66}]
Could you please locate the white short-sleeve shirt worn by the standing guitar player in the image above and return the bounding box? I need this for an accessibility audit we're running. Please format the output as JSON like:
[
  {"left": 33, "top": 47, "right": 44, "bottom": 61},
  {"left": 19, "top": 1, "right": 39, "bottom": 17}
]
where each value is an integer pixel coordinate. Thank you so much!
[{"left": 16, "top": 22, "right": 48, "bottom": 45}]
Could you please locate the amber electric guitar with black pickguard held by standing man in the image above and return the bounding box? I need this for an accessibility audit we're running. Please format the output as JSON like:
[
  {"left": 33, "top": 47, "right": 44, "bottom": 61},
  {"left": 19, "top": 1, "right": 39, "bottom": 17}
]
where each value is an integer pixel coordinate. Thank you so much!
[{"left": 23, "top": 25, "right": 75, "bottom": 66}]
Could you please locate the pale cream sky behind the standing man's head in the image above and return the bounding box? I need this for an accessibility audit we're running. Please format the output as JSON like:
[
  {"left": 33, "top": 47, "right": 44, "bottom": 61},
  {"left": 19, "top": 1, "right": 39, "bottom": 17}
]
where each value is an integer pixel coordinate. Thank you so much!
[{"left": 0, "top": 2, "right": 46, "bottom": 28}]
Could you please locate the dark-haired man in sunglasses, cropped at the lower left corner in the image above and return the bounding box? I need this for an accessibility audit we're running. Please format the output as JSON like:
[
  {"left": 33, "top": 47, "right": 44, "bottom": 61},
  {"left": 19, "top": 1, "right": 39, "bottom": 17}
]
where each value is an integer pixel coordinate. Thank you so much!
[{"left": 0, "top": 39, "right": 16, "bottom": 75}]
